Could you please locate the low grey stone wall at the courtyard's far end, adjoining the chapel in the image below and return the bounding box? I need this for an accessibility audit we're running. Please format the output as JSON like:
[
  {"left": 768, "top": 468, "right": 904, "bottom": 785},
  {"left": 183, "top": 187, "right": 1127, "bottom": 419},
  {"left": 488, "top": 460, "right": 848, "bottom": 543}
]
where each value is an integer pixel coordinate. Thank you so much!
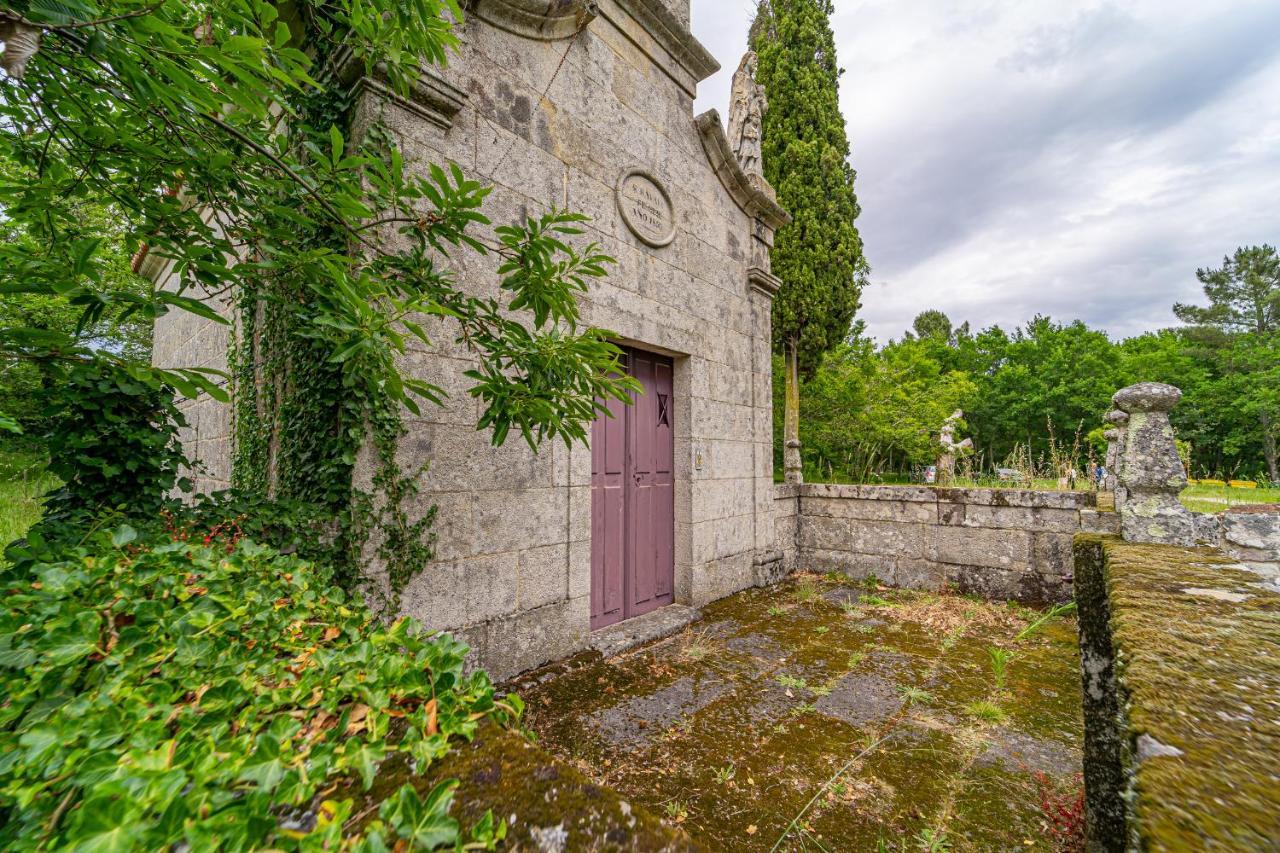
[{"left": 776, "top": 483, "right": 1119, "bottom": 603}]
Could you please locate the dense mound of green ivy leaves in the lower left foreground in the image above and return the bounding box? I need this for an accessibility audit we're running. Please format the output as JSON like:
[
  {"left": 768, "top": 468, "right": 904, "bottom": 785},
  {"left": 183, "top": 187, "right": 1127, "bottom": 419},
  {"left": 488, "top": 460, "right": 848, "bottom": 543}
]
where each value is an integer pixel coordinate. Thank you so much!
[{"left": 0, "top": 526, "right": 520, "bottom": 850}]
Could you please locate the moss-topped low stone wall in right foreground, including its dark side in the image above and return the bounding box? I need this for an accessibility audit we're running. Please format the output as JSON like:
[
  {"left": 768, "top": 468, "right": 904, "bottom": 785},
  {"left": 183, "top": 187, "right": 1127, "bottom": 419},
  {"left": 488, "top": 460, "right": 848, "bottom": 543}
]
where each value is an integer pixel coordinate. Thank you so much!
[{"left": 1075, "top": 534, "right": 1280, "bottom": 850}]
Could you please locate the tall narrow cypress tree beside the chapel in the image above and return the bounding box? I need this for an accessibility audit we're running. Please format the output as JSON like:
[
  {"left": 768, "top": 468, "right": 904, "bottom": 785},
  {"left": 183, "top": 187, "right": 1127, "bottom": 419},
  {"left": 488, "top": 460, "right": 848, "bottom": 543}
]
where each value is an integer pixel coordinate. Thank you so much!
[{"left": 750, "top": 0, "right": 868, "bottom": 478}]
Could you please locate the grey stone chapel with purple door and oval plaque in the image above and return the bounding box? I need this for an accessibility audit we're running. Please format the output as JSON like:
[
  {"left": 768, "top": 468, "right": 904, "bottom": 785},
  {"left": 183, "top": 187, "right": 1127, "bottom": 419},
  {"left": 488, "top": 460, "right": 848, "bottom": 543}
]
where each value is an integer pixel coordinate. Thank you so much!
[{"left": 143, "top": 0, "right": 787, "bottom": 678}]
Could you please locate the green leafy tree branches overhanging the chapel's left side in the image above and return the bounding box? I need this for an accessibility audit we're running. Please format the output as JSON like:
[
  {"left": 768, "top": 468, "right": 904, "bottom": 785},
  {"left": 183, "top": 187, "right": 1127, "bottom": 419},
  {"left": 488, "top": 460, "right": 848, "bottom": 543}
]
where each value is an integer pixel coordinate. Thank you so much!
[{"left": 0, "top": 0, "right": 622, "bottom": 450}]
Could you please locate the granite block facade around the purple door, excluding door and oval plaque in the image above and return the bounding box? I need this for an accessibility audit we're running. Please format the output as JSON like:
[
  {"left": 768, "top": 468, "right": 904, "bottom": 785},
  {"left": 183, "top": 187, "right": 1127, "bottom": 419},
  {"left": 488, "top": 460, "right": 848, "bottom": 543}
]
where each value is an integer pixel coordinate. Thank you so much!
[{"left": 340, "top": 0, "right": 777, "bottom": 678}]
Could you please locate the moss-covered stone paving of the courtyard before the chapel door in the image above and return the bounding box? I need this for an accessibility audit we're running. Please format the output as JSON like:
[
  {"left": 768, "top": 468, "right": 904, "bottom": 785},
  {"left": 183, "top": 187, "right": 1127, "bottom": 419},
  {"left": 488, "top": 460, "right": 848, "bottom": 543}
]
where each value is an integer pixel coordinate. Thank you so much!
[{"left": 515, "top": 575, "right": 1083, "bottom": 850}]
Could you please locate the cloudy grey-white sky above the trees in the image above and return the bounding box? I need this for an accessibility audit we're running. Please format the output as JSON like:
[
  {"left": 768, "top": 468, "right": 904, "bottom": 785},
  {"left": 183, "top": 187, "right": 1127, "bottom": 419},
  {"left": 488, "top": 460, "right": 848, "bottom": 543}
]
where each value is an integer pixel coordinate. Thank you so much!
[{"left": 692, "top": 0, "right": 1280, "bottom": 341}]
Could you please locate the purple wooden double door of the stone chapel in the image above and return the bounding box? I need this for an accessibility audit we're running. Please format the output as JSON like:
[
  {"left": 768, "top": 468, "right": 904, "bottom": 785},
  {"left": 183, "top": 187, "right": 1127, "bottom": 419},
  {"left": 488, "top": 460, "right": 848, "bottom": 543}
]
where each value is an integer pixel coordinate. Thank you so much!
[{"left": 591, "top": 350, "right": 676, "bottom": 629}]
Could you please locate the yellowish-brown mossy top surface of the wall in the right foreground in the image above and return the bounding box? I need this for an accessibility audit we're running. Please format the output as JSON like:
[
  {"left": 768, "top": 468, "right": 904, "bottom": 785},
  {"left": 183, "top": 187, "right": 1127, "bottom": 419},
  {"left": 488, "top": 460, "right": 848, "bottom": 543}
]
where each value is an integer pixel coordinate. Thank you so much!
[{"left": 1103, "top": 540, "right": 1280, "bottom": 850}]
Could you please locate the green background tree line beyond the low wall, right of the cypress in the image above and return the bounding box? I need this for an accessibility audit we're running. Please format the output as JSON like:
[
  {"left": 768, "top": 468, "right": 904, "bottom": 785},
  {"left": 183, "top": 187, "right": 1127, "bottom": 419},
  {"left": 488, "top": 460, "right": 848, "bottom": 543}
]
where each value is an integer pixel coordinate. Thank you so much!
[{"left": 774, "top": 246, "right": 1280, "bottom": 482}]
